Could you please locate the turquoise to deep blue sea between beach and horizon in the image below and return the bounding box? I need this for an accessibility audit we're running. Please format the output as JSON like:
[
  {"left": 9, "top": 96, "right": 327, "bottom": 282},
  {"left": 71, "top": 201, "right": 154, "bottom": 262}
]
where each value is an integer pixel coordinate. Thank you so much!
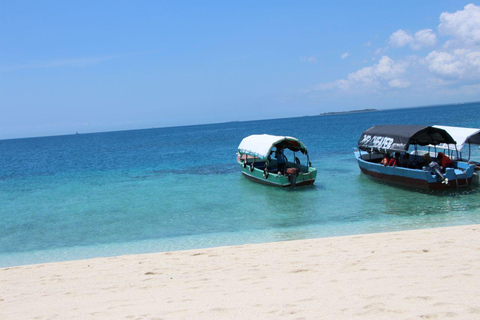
[{"left": 0, "top": 103, "right": 480, "bottom": 267}]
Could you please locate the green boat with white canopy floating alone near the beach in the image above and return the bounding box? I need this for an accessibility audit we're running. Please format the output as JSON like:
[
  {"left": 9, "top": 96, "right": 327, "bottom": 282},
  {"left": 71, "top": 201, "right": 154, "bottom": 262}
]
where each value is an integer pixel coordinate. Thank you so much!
[{"left": 237, "top": 134, "right": 317, "bottom": 187}]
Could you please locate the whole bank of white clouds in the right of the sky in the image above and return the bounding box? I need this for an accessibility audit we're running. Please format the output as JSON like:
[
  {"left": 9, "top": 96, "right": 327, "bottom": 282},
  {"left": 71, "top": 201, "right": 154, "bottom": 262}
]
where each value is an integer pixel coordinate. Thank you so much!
[{"left": 305, "top": 4, "right": 480, "bottom": 97}]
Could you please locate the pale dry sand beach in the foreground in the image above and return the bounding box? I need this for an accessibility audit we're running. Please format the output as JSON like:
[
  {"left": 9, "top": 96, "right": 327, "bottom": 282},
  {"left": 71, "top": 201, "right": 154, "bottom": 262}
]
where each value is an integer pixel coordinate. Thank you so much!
[{"left": 0, "top": 225, "right": 480, "bottom": 319}]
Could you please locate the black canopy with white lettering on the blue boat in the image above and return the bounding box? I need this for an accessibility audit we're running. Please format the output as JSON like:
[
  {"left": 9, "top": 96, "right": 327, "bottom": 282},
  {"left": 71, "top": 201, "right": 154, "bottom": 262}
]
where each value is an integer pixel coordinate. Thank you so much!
[{"left": 358, "top": 125, "right": 455, "bottom": 152}]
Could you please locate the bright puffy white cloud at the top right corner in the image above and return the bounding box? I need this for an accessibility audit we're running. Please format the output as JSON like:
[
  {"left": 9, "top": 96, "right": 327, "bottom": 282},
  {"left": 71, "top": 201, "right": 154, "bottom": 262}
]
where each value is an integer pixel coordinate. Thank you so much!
[{"left": 438, "top": 3, "right": 480, "bottom": 45}]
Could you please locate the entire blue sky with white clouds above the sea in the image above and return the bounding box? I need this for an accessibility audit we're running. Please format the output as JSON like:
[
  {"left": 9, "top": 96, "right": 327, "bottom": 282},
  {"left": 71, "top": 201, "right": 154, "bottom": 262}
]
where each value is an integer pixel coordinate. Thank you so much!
[{"left": 0, "top": 0, "right": 480, "bottom": 139}]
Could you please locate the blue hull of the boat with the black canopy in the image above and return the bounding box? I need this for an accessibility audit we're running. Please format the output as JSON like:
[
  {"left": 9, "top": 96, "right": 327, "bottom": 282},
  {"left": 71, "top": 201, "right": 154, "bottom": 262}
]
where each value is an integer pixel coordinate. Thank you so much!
[{"left": 356, "top": 152, "right": 474, "bottom": 190}]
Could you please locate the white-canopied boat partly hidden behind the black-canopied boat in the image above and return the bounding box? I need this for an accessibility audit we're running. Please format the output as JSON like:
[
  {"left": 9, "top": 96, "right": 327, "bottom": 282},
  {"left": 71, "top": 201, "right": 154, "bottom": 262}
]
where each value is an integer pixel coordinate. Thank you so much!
[{"left": 434, "top": 125, "right": 480, "bottom": 170}]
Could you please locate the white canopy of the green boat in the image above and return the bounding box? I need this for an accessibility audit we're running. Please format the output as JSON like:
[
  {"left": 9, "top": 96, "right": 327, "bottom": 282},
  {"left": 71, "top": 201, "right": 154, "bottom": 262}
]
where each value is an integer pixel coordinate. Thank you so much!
[{"left": 238, "top": 134, "right": 307, "bottom": 159}]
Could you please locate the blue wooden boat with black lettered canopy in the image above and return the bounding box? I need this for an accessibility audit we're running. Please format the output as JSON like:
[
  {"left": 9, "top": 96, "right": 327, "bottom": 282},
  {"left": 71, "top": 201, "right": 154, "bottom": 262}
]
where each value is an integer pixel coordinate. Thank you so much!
[{"left": 355, "top": 125, "right": 475, "bottom": 190}]
